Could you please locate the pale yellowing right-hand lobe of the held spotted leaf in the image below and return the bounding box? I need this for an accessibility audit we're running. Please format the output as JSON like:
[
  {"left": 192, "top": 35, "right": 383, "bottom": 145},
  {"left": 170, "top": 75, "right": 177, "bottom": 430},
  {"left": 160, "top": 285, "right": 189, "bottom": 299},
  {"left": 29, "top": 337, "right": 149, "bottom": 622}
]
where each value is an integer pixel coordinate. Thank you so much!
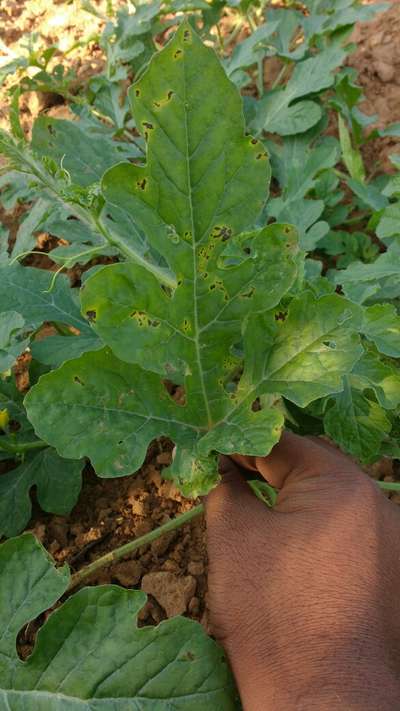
[{"left": 239, "top": 291, "right": 362, "bottom": 407}]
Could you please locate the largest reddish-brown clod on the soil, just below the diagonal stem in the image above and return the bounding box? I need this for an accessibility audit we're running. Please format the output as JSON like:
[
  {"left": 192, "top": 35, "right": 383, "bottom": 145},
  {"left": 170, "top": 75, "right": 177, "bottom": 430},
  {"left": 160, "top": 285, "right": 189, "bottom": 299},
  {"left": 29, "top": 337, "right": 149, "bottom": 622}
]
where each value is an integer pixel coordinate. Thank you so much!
[{"left": 142, "top": 571, "right": 196, "bottom": 617}]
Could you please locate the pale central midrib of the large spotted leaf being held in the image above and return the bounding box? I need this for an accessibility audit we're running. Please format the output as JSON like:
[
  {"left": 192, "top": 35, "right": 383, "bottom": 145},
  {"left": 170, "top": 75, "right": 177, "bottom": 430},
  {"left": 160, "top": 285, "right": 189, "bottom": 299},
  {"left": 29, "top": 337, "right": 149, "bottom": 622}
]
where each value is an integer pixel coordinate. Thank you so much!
[{"left": 183, "top": 57, "right": 213, "bottom": 429}]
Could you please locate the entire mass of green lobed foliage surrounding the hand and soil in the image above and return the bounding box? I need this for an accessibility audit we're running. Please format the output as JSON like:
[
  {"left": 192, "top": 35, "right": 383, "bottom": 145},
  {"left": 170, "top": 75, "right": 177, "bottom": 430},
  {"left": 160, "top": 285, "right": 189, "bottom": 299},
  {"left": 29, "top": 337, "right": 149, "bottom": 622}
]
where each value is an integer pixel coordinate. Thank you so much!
[{"left": 0, "top": 0, "right": 400, "bottom": 711}]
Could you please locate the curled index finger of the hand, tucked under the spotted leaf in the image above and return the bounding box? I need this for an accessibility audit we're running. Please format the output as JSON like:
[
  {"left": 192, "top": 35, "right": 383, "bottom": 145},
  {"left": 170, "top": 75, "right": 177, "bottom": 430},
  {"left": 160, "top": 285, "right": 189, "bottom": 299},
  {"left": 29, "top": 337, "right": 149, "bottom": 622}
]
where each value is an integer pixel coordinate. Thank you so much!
[{"left": 255, "top": 432, "right": 356, "bottom": 489}]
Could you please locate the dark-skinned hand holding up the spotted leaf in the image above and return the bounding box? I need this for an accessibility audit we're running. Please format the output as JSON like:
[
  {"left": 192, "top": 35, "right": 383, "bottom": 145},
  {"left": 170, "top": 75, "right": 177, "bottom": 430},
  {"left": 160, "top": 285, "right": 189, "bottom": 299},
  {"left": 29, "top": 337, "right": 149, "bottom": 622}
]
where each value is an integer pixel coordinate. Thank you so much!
[{"left": 206, "top": 433, "right": 400, "bottom": 711}]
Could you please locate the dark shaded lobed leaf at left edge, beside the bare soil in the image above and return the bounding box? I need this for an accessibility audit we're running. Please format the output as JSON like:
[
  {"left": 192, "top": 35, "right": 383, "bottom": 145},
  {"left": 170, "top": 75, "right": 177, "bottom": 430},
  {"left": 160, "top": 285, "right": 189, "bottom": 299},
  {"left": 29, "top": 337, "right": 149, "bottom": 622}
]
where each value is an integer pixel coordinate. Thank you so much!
[{"left": 0, "top": 448, "right": 83, "bottom": 536}]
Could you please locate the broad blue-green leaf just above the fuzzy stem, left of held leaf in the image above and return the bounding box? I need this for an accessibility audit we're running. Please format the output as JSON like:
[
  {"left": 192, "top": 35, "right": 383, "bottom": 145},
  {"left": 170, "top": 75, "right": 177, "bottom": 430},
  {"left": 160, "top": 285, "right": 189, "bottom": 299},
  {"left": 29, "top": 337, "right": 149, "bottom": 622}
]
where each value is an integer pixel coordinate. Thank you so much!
[{"left": 32, "top": 116, "right": 136, "bottom": 186}]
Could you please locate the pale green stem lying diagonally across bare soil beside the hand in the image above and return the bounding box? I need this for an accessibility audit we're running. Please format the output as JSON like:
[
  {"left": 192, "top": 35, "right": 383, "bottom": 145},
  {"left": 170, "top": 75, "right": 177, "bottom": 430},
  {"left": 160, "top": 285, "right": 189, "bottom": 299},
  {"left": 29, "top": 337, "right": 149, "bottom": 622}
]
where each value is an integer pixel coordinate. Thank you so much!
[{"left": 69, "top": 504, "right": 204, "bottom": 590}]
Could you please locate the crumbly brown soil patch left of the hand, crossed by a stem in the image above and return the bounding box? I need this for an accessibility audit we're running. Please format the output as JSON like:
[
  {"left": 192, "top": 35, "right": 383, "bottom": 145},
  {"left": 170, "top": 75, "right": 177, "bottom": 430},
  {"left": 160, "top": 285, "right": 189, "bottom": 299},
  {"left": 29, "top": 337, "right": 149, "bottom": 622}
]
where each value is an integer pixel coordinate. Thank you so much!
[{"left": 28, "top": 440, "right": 206, "bottom": 623}]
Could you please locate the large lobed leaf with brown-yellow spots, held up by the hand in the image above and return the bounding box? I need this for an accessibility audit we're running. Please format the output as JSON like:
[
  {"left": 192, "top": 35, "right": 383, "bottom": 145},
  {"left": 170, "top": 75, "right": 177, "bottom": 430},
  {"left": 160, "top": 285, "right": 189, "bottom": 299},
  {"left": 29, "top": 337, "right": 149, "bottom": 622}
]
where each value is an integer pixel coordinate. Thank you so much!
[{"left": 26, "top": 24, "right": 361, "bottom": 496}]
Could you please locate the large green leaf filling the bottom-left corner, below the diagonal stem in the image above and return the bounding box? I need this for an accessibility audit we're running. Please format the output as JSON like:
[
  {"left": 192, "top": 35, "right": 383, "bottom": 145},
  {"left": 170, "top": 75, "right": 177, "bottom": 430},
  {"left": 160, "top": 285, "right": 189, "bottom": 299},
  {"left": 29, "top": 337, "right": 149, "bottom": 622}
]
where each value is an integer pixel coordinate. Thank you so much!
[{"left": 0, "top": 535, "right": 239, "bottom": 711}]
